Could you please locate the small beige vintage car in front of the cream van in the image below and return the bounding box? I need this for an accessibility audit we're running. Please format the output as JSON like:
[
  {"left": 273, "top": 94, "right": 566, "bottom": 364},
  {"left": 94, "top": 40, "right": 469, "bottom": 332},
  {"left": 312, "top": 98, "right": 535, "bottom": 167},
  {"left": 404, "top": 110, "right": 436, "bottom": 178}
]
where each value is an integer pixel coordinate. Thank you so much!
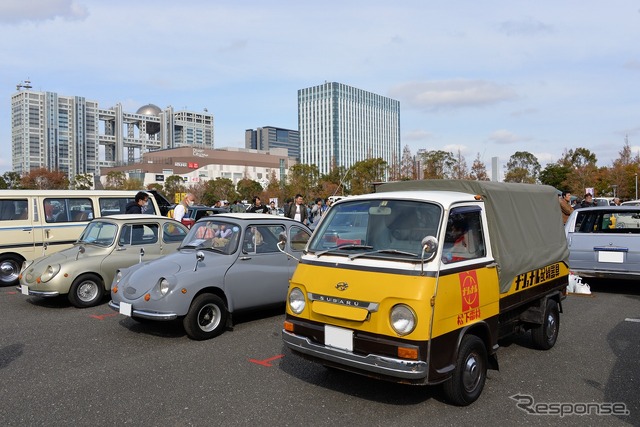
[{"left": 18, "top": 215, "right": 189, "bottom": 307}]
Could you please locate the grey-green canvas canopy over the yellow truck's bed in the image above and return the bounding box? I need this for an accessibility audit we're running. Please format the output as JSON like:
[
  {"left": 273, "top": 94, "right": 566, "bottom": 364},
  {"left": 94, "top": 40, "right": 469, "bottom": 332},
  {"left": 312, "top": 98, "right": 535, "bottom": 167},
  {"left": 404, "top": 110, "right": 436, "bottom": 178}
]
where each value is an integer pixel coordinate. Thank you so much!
[{"left": 376, "top": 179, "right": 569, "bottom": 293}]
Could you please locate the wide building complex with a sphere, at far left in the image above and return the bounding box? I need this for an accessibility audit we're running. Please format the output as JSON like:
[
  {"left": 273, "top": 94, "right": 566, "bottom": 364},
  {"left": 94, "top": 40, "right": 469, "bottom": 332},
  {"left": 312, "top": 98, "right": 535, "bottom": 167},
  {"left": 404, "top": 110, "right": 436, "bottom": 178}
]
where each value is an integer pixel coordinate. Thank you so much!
[{"left": 11, "top": 85, "right": 213, "bottom": 178}]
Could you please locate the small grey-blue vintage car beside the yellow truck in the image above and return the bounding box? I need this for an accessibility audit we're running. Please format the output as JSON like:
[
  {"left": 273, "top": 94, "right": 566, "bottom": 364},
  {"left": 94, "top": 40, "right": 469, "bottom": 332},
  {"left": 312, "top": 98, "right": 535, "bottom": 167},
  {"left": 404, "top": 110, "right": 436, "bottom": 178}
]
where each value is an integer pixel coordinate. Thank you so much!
[{"left": 109, "top": 213, "right": 311, "bottom": 340}]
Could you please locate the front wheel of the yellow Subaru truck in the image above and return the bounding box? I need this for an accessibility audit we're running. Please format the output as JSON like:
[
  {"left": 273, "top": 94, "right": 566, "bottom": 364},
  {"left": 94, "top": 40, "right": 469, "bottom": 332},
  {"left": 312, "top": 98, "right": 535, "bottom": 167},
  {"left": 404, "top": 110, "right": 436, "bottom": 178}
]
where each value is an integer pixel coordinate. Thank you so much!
[{"left": 444, "top": 335, "right": 487, "bottom": 406}]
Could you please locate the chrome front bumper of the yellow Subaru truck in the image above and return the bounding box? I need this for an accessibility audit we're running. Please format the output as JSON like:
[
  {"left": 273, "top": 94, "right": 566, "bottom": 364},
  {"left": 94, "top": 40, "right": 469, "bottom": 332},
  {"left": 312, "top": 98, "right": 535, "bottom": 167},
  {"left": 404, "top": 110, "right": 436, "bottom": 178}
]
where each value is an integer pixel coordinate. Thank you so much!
[{"left": 282, "top": 330, "right": 427, "bottom": 380}]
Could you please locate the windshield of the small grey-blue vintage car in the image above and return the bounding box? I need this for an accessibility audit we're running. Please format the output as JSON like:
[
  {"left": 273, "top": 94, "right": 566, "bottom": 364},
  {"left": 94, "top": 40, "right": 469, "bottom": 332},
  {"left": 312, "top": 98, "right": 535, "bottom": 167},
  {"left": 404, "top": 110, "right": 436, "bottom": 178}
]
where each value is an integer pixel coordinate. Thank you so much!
[{"left": 181, "top": 219, "right": 240, "bottom": 254}]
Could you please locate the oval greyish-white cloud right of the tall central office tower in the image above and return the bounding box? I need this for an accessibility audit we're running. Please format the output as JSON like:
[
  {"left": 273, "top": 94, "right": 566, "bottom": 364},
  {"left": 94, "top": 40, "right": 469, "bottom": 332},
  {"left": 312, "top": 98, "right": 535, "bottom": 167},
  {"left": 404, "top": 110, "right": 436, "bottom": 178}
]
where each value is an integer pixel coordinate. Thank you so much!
[{"left": 389, "top": 79, "right": 517, "bottom": 111}]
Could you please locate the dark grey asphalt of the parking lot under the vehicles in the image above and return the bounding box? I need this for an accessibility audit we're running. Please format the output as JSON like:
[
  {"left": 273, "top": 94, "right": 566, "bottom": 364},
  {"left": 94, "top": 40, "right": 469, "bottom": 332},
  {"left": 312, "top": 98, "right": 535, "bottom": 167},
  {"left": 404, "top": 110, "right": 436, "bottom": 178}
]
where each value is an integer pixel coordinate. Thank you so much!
[{"left": 0, "top": 280, "right": 640, "bottom": 426}]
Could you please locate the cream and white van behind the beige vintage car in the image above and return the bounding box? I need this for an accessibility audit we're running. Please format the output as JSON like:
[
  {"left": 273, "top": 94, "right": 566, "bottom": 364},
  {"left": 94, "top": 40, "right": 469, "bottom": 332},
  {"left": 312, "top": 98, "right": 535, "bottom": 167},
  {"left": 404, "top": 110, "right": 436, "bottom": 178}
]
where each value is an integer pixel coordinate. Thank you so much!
[{"left": 0, "top": 190, "right": 160, "bottom": 286}]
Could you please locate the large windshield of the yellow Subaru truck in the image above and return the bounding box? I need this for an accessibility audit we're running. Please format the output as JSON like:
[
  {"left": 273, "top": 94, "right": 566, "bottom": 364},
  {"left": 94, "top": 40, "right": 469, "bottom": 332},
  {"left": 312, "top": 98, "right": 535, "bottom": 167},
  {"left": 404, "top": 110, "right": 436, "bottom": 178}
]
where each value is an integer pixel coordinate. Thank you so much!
[{"left": 309, "top": 199, "right": 442, "bottom": 261}]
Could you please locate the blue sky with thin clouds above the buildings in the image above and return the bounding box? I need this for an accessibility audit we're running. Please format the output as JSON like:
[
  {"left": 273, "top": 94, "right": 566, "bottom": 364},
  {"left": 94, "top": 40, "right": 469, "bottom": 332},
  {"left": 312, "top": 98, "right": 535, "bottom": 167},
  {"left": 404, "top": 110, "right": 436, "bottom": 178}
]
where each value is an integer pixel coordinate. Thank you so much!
[{"left": 0, "top": 0, "right": 640, "bottom": 176}]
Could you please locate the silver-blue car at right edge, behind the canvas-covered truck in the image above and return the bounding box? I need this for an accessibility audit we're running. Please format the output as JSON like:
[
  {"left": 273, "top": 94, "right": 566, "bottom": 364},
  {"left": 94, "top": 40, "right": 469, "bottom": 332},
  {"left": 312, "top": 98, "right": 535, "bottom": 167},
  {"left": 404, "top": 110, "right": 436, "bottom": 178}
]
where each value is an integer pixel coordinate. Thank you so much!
[{"left": 565, "top": 205, "right": 640, "bottom": 279}]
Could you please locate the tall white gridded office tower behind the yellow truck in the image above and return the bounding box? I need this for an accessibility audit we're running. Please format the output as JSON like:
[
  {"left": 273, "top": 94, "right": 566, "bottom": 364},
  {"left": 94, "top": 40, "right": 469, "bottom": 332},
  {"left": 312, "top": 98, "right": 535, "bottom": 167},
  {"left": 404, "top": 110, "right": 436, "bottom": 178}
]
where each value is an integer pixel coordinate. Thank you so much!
[{"left": 298, "top": 82, "right": 400, "bottom": 174}]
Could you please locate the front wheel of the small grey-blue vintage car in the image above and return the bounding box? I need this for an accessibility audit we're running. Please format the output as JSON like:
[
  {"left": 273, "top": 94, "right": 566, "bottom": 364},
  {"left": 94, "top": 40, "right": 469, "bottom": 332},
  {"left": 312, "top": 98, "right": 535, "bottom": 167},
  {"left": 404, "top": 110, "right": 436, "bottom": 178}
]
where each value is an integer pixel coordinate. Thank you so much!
[{"left": 182, "top": 294, "right": 228, "bottom": 340}]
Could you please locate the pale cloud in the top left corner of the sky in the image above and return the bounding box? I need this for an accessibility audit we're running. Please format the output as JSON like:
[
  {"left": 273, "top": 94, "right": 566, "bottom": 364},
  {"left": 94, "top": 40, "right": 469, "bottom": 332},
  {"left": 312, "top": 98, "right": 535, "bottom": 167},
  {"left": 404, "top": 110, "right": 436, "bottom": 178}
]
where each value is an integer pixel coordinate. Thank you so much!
[{"left": 0, "top": 0, "right": 89, "bottom": 24}]
